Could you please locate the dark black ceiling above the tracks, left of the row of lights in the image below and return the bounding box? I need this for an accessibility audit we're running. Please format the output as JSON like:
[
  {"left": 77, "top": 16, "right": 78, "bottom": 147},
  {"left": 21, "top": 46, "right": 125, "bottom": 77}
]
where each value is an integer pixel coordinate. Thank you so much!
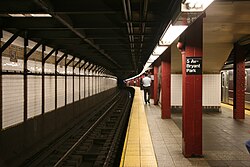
[{"left": 0, "top": 0, "right": 181, "bottom": 78}]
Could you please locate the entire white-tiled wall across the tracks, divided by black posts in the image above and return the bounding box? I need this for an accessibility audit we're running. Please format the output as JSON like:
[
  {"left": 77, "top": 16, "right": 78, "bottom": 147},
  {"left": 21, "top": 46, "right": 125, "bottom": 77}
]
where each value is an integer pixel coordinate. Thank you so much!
[{"left": 1, "top": 40, "right": 116, "bottom": 129}]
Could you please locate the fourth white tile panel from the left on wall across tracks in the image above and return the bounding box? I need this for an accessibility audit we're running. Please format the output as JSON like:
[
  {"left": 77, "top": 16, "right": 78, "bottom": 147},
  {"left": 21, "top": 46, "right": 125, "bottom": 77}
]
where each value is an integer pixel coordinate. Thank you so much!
[{"left": 57, "top": 76, "right": 65, "bottom": 108}]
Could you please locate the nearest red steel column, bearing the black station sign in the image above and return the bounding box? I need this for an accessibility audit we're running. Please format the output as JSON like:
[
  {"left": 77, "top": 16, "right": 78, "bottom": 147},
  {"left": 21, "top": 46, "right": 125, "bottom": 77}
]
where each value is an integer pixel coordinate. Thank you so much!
[{"left": 182, "top": 17, "right": 203, "bottom": 157}]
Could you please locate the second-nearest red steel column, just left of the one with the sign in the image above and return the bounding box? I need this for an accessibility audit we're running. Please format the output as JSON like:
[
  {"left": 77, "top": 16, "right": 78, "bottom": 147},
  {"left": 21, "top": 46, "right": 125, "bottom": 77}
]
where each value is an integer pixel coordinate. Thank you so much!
[{"left": 161, "top": 47, "right": 171, "bottom": 119}]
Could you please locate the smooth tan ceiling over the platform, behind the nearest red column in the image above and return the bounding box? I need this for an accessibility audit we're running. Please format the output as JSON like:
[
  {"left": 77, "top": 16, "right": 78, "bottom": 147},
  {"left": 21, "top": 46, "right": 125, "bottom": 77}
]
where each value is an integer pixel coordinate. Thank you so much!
[{"left": 171, "top": 0, "right": 250, "bottom": 73}]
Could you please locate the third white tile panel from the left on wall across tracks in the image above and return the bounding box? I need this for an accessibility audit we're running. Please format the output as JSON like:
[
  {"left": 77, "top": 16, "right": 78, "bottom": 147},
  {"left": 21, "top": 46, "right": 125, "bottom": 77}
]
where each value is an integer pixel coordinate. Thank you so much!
[{"left": 44, "top": 76, "right": 55, "bottom": 112}]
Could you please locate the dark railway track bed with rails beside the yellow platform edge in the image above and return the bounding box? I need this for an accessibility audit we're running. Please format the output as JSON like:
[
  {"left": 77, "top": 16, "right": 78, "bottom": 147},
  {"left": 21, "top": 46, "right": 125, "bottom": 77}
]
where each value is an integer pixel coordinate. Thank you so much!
[{"left": 22, "top": 90, "right": 132, "bottom": 167}]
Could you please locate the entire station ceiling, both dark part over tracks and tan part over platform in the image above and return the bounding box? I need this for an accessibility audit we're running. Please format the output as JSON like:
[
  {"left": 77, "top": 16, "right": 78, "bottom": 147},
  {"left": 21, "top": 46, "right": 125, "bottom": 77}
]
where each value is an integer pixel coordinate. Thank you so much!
[{"left": 0, "top": 0, "right": 250, "bottom": 79}]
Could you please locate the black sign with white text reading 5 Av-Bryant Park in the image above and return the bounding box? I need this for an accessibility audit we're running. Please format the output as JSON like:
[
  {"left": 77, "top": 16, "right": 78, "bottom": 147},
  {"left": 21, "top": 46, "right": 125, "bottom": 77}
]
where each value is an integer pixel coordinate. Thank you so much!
[{"left": 186, "top": 57, "right": 202, "bottom": 75}]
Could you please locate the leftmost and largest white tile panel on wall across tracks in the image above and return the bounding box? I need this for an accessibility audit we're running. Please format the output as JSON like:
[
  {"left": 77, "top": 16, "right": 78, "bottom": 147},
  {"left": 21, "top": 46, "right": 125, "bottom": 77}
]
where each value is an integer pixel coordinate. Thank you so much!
[{"left": 2, "top": 75, "right": 24, "bottom": 128}]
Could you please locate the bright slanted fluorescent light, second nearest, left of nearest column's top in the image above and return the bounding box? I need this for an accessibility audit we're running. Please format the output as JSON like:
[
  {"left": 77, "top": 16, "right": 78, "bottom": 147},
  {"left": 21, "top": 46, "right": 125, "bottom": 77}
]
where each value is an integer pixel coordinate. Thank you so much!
[{"left": 159, "top": 24, "right": 188, "bottom": 45}]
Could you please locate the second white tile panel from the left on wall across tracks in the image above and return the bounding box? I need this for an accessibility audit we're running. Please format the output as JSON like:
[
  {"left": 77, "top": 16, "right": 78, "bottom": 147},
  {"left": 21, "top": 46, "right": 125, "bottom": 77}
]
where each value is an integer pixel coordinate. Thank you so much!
[{"left": 27, "top": 75, "right": 42, "bottom": 118}]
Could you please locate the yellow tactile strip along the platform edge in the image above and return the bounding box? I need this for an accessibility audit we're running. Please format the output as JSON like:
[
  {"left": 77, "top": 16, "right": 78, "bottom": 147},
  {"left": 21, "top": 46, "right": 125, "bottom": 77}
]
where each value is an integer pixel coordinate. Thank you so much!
[{"left": 120, "top": 87, "right": 157, "bottom": 167}]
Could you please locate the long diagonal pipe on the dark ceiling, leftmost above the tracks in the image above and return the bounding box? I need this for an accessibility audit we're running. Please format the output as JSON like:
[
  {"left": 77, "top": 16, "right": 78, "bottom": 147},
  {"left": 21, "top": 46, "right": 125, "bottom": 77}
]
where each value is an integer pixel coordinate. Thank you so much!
[{"left": 34, "top": 0, "right": 122, "bottom": 68}]
